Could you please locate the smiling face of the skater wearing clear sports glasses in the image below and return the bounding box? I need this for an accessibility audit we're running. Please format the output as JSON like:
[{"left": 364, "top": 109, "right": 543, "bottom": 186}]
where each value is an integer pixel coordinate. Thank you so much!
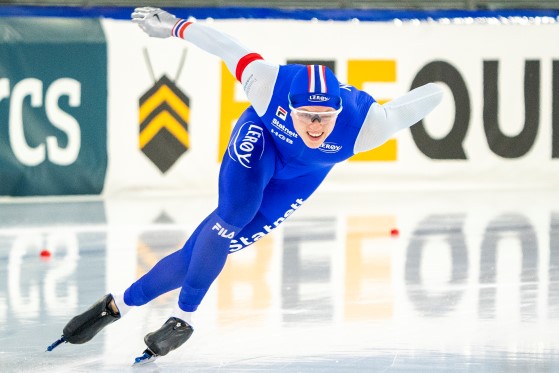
[{"left": 291, "top": 106, "right": 339, "bottom": 149}]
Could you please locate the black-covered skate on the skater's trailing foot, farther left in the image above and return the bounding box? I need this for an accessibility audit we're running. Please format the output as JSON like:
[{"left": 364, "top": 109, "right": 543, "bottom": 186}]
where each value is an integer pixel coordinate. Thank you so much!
[{"left": 47, "top": 294, "right": 120, "bottom": 351}]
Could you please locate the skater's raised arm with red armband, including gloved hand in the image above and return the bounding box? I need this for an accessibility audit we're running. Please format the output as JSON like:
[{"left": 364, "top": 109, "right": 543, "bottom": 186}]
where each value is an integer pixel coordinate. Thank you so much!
[{"left": 132, "top": 7, "right": 279, "bottom": 115}]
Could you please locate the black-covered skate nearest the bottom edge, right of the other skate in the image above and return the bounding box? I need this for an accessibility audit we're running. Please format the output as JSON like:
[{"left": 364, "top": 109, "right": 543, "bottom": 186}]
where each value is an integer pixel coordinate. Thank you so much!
[{"left": 133, "top": 317, "right": 194, "bottom": 365}]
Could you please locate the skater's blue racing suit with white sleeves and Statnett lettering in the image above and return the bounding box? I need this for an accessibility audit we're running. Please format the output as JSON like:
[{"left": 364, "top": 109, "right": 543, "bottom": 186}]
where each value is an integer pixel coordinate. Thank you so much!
[{"left": 124, "top": 22, "right": 442, "bottom": 312}]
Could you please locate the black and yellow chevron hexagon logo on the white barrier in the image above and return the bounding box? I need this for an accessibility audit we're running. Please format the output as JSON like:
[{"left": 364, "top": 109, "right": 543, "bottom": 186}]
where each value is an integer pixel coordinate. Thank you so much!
[{"left": 140, "top": 75, "right": 190, "bottom": 173}]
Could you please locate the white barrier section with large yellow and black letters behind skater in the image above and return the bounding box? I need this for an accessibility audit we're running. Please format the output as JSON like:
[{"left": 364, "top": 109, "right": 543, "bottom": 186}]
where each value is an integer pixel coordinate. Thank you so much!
[{"left": 103, "top": 16, "right": 559, "bottom": 194}]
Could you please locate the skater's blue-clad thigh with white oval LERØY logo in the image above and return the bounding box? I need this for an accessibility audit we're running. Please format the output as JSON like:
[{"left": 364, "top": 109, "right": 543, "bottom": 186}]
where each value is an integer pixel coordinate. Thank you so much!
[{"left": 217, "top": 107, "right": 276, "bottom": 228}]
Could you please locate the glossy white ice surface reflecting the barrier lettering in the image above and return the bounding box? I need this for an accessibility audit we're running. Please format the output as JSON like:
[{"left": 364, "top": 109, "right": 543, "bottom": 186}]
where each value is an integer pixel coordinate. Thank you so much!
[{"left": 0, "top": 189, "right": 559, "bottom": 373}]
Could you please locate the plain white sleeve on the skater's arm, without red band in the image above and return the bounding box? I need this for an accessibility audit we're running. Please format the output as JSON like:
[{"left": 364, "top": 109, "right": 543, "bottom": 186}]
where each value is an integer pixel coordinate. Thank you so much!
[{"left": 353, "top": 83, "right": 443, "bottom": 154}]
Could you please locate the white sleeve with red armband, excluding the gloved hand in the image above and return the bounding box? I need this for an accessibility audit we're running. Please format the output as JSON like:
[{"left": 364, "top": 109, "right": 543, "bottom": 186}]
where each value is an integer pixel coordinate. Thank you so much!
[{"left": 177, "top": 22, "right": 279, "bottom": 116}]
